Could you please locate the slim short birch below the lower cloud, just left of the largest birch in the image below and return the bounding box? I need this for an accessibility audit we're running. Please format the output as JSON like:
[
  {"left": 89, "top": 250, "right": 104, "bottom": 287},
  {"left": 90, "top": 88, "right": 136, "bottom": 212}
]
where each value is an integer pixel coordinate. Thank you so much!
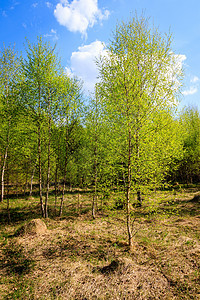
[{"left": 84, "top": 86, "right": 116, "bottom": 219}]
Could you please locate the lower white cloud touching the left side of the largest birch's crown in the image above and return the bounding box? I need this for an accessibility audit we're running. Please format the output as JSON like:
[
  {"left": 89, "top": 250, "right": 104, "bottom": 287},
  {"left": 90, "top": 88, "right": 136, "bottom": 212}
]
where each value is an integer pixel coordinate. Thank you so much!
[{"left": 66, "top": 41, "right": 106, "bottom": 92}]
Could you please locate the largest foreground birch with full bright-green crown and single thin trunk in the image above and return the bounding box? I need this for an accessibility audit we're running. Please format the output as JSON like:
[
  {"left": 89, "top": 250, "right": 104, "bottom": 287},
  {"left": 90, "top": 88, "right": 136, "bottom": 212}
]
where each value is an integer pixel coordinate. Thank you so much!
[{"left": 98, "top": 16, "right": 184, "bottom": 248}]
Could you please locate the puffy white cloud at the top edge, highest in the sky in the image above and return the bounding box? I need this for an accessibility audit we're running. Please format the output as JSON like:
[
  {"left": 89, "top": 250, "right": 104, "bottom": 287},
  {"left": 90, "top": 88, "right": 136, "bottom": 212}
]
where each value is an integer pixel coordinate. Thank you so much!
[{"left": 54, "top": 0, "right": 109, "bottom": 35}]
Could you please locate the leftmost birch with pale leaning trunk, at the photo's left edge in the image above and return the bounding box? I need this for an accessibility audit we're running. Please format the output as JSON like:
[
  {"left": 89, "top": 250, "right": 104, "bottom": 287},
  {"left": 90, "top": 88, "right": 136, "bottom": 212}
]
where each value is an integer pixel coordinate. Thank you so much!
[{"left": 0, "top": 47, "right": 20, "bottom": 202}]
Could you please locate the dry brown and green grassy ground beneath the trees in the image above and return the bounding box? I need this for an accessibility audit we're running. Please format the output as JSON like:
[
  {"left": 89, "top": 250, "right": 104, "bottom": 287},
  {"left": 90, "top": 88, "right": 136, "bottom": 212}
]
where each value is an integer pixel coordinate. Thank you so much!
[{"left": 0, "top": 187, "right": 200, "bottom": 300}]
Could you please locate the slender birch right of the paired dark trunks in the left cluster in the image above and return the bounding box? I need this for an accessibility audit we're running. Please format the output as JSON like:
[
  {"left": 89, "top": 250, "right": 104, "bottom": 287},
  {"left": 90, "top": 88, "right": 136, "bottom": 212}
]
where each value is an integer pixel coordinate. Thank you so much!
[{"left": 52, "top": 74, "right": 82, "bottom": 216}]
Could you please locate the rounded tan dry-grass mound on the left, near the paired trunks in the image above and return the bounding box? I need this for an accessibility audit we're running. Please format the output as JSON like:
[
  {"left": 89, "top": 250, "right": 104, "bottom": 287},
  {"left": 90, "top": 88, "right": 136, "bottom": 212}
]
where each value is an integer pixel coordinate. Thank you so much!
[{"left": 16, "top": 219, "right": 47, "bottom": 236}]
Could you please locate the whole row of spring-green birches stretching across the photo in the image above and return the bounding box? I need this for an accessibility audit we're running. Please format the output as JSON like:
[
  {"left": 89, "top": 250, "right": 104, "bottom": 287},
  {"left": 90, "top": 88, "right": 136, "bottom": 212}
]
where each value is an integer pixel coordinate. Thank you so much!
[{"left": 0, "top": 16, "right": 200, "bottom": 246}]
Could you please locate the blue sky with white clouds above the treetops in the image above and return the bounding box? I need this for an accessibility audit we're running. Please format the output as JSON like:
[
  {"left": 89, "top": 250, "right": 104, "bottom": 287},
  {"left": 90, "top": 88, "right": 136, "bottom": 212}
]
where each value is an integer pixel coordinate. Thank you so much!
[{"left": 0, "top": 0, "right": 200, "bottom": 108}]
